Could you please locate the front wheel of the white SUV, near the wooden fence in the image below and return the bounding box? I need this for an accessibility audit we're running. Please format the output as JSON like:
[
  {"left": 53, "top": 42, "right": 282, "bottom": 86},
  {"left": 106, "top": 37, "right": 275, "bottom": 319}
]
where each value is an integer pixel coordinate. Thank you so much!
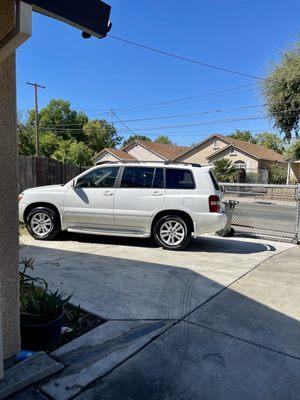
[{"left": 26, "top": 207, "right": 60, "bottom": 240}]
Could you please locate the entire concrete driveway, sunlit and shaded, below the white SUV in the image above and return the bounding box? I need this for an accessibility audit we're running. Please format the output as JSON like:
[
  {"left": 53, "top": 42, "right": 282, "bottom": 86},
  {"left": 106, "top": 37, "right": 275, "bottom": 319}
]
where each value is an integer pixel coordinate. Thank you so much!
[{"left": 21, "top": 235, "right": 300, "bottom": 400}]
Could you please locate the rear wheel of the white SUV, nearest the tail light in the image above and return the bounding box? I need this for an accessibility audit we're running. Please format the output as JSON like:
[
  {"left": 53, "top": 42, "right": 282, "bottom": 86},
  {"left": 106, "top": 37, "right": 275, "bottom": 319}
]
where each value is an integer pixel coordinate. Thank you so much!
[{"left": 153, "top": 215, "right": 191, "bottom": 250}]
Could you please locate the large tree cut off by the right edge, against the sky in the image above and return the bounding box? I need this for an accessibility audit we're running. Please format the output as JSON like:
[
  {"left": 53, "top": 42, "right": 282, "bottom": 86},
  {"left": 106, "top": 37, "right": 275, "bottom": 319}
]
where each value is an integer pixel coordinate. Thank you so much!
[{"left": 262, "top": 42, "right": 300, "bottom": 140}]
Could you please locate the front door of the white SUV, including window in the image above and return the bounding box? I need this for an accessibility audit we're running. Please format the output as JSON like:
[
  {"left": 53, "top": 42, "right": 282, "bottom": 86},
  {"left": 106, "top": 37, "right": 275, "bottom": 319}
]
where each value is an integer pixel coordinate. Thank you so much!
[{"left": 64, "top": 166, "right": 120, "bottom": 229}]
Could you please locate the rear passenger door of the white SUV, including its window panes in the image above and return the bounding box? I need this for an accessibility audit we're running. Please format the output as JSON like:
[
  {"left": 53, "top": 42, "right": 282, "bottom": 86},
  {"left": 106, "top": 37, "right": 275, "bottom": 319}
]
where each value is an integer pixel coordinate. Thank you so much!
[{"left": 114, "top": 166, "right": 165, "bottom": 233}]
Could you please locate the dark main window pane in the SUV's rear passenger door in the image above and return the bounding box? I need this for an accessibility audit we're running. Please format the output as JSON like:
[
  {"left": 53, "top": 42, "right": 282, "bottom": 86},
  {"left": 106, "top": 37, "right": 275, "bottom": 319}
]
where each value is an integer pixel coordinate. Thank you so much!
[{"left": 121, "top": 167, "right": 154, "bottom": 188}]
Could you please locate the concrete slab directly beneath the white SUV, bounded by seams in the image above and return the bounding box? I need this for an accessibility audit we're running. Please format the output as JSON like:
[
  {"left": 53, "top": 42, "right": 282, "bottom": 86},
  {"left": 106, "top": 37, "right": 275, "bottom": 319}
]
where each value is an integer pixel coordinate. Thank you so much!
[{"left": 21, "top": 235, "right": 291, "bottom": 320}]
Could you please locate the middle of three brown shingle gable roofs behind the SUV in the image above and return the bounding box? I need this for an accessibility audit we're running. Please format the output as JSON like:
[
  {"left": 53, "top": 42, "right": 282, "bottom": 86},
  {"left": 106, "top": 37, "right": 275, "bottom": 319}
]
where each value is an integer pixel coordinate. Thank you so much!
[{"left": 123, "top": 140, "right": 190, "bottom": 160}]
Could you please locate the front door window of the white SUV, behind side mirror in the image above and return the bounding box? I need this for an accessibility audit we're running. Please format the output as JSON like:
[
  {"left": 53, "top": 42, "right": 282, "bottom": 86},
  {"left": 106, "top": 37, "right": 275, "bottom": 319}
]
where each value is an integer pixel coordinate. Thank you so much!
[{"left": 76, "top": 167, "right": 119, "bottom": 188}]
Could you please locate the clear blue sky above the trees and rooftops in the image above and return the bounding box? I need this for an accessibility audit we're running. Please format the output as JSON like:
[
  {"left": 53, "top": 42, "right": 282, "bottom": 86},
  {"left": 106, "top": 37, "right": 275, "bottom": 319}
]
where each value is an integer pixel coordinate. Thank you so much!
[{"left": 17, "top": 0, "right": 300, "bottom": 145}]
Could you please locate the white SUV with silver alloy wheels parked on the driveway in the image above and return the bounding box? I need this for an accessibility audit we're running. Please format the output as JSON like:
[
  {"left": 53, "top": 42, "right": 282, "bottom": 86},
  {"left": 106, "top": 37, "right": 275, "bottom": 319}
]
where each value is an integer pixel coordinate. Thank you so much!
[{"left": 19, "top": 162, "right": 226, "bottom": 250}]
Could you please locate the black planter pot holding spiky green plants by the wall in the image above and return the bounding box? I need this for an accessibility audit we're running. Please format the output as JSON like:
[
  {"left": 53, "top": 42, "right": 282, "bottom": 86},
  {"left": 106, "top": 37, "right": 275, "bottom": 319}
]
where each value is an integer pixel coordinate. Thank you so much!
[{"left": 21, "top": 313, "right": 64, "bottom": 351}]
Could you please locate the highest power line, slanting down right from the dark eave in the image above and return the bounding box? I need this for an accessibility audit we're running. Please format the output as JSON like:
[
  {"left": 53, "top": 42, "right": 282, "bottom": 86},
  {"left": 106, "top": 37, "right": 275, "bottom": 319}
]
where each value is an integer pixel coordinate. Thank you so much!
[{"left": 107, "top": 34, "right": 264, "bottom": 80}]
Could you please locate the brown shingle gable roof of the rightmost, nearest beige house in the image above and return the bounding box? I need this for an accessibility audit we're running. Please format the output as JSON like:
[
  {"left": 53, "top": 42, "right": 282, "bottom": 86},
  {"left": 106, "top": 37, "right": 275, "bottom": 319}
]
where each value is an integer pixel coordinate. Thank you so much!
[{"left": 177, "top": 134, "right": 285, "bottom": 162}]
